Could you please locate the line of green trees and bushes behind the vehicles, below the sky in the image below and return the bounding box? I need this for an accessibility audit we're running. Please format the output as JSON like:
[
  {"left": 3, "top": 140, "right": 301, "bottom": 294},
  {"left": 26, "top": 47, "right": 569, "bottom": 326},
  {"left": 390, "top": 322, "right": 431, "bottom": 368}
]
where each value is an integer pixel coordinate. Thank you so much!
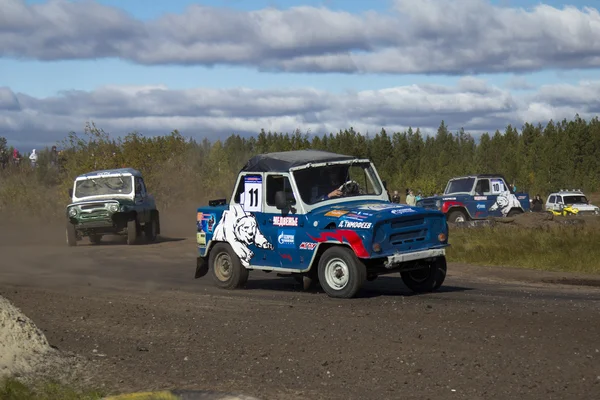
[{"left": 0, "top": 115, "right": 600, "bottom": 212}]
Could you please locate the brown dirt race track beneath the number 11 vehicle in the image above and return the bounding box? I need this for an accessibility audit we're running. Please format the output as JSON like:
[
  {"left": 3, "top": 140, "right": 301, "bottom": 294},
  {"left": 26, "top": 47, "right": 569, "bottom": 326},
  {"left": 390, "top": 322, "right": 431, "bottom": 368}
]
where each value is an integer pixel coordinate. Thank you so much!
[{"left": 0, "top": 215, "right": 600, "bottom": 400}]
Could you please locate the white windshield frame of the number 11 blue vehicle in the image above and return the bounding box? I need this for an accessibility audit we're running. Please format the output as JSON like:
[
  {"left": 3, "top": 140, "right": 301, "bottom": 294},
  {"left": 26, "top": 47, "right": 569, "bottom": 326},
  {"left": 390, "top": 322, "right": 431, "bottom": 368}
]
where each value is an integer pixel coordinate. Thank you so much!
[{"left": 289, "top": 158, "right": 390, "bottom": 213}]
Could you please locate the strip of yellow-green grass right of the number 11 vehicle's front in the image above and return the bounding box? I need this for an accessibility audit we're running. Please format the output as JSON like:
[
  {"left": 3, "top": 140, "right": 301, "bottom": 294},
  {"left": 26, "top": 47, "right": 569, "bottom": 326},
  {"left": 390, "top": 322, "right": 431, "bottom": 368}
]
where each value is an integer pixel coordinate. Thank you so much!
[{"left": 448, "top": 221, "right": 600, "bottom": 274}]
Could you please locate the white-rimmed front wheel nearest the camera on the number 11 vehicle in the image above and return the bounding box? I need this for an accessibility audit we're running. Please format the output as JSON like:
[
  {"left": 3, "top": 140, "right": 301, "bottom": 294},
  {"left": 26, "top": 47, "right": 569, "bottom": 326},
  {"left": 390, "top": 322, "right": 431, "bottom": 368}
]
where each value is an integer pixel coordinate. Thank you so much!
[{"left": 318, "top": 246, "right": 367, "bottom": 299}]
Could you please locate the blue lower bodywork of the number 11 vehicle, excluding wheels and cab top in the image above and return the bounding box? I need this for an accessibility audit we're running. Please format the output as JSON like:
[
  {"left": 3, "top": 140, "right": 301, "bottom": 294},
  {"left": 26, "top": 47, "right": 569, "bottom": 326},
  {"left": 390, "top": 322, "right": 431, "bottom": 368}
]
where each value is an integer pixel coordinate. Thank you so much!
[{"left": 197, "top": 200, "right": 448, "bottom": 271}]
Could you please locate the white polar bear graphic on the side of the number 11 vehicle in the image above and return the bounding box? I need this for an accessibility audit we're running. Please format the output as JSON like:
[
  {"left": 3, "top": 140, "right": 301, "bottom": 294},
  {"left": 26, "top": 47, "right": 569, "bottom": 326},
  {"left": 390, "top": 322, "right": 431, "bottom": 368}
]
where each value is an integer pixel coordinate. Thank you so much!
[{"left": 213, "top": 204, "right": 273, "bottom": 268}]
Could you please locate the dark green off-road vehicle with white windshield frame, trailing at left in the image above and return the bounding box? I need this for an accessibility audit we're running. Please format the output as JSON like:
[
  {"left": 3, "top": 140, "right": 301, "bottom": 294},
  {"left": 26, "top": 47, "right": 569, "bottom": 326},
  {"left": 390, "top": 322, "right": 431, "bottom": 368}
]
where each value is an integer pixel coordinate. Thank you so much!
[{"left": 66, "top": 168, "right": 160, "bottom": 246}]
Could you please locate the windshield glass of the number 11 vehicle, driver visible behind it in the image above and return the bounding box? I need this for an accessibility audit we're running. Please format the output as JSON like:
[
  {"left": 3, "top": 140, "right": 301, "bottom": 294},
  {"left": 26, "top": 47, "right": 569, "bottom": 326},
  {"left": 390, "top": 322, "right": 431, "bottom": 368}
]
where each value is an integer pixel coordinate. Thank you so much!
[{"left": 294, "top": 163, "right": 382, "bottom": 204}]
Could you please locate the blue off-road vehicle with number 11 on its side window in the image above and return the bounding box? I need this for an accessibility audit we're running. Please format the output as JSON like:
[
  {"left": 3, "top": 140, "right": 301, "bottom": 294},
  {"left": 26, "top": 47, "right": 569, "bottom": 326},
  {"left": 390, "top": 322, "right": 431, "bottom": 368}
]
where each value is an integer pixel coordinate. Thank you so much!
[{"left": 196, "top": 150, "right": 448, "bottom": 298}]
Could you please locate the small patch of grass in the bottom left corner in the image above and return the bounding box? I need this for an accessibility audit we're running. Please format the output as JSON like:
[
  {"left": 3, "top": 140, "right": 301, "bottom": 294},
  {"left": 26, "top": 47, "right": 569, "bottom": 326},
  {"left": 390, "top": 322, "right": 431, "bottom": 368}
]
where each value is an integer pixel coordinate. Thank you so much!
[{"left": 0, "top": 378, "right": 104, "bottom": 400}]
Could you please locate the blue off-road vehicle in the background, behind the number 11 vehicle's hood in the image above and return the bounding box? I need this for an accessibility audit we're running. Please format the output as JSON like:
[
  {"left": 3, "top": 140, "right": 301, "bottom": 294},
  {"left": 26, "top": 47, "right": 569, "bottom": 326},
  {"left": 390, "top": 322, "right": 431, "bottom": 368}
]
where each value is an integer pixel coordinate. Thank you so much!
[{"left": 417, "top": 174, "right": 530, "bottom": 223}]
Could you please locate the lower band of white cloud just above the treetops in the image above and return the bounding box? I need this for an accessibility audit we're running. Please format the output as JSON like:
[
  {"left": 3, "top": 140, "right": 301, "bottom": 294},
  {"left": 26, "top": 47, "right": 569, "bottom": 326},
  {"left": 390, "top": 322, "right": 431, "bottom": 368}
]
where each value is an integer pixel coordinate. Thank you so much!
[{"left": 0, "top": 77, "right": 600, "bottom": 147}]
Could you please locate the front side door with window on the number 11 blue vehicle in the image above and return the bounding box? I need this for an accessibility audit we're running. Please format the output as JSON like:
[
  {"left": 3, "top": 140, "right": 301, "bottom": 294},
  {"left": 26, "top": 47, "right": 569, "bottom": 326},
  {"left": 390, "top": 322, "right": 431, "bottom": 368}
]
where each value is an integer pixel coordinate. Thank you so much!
[{"left": 261, "top": 173, "right": 305, "bottom": 269}]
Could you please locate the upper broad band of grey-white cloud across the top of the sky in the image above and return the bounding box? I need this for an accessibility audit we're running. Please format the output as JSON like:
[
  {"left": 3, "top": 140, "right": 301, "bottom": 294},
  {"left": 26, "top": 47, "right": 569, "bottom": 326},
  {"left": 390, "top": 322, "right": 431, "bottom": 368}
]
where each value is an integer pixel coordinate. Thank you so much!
[{"left": 0, "top": 0, "right": 600, "bottom": 74}]
